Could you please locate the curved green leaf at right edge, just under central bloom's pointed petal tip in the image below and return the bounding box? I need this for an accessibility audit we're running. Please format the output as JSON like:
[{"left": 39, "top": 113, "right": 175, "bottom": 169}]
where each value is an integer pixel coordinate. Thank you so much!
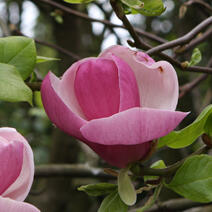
[{"left": 157, "top": 105, "right": 212, "bottom": 149}]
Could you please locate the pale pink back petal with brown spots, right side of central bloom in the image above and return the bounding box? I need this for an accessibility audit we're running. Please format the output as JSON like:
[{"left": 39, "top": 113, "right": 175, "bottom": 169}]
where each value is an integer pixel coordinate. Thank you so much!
[{"left": 100, "top": 45, "right": 179, "bottom": 110}]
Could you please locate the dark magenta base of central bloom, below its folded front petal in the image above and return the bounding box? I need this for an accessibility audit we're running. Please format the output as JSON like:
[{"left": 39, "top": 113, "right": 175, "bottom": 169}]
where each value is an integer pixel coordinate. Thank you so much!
[{"left": 85, "top": 142, "right": 151, "bottom": 168}]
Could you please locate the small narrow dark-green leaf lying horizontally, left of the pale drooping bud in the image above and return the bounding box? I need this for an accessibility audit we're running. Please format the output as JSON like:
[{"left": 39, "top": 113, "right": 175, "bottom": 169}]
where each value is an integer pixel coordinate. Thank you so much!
[{"left": 78, "top": 183, "right": 117, "bottom": 196}]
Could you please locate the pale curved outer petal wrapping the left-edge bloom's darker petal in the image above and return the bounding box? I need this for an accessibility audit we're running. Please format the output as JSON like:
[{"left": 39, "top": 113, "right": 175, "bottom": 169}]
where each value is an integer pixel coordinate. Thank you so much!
[{"left": 0, "top": 127, "right": 34, "bottom": 201}]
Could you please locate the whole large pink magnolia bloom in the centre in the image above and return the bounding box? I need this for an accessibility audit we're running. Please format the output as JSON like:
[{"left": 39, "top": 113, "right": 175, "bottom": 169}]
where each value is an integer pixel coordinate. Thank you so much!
[{"left": 41, "top": 46, "right": 187, "bottom": 168}]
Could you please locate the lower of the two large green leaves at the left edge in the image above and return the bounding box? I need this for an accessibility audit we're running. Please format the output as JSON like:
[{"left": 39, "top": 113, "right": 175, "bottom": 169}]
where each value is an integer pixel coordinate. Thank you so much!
[{"left": 0, "top": 63, "right": 32, "bottom": 105}]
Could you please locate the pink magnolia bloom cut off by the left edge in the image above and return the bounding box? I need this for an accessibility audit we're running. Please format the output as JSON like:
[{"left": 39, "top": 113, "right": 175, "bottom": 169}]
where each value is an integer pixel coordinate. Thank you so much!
[{"left": 0, "top": 127, "right": 39, "bottom": 212}]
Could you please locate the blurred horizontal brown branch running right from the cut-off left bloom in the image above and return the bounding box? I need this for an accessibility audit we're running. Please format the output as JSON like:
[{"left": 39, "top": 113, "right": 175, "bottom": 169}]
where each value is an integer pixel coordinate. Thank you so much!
[{"left": 35, "top": 164, "right": 116, "bottom": 179}]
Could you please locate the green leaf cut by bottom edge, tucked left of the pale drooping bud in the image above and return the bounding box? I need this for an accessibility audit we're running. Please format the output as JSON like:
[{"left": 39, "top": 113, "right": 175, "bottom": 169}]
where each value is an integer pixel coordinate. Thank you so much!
[{"left": 98, "top": 191, "right": 128, "bottom": 212}]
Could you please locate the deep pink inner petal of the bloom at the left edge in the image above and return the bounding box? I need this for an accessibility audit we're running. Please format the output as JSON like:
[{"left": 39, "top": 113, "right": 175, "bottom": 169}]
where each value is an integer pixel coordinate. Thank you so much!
[{"left": 0, "top": 139, "right": 24, "bottom": 194}]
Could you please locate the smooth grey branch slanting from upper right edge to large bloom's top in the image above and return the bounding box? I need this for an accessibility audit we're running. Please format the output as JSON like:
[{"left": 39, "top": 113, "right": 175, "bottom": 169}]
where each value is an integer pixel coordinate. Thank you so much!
[{"left": 146, "top": 16, "right": 212, "bottom": 55}]
